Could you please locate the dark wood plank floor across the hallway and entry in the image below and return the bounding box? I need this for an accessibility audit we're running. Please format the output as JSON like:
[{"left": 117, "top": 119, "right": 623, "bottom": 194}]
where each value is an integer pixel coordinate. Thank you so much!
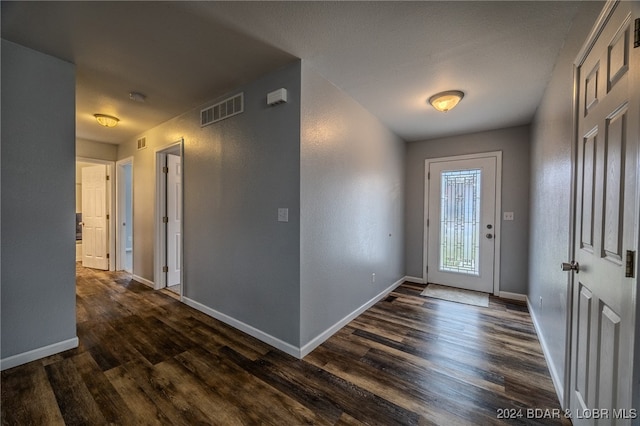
[{"left": 1, "top": 268, "right": 569, "bottom": 425}]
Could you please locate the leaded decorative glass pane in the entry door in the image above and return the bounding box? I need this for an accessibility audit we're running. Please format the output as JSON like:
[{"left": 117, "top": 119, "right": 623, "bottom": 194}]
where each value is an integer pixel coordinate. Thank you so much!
[{"left": 439, "top": 169, "right": 482, "bottom": 276}]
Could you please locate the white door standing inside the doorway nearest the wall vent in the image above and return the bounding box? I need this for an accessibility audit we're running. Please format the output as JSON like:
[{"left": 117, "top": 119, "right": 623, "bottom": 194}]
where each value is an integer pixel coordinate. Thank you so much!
[{"left": 167, "top": 154, "right": 182, "bottom": 287}]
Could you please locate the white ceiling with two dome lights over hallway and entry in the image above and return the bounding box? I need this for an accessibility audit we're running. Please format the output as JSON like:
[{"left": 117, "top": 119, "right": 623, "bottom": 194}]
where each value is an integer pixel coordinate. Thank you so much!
[{"left": 2, "top": 1, "right": 580, "bottom": 143}]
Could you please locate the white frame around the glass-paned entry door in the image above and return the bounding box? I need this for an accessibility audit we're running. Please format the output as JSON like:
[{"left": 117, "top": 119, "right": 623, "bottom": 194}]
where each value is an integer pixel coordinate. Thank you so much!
[{"left": 422, "top": 151, "right": 502, "bottom": 296}]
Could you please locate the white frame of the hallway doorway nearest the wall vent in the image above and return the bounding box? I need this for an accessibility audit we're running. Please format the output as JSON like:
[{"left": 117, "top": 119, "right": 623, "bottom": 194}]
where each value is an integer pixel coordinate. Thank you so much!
[{"left": 153, "top": 139, "right": 184, "bottom": 292}]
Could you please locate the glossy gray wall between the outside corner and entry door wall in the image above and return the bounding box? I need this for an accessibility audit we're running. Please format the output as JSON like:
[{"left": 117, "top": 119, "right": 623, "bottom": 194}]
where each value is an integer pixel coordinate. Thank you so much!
[{"left": 300, "top": 63, "right": 405, "bottom": 346}]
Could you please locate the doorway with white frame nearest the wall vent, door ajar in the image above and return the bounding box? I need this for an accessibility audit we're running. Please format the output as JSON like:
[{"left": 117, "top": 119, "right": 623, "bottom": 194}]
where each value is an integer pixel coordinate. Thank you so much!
[{"left": 154, "top": 139, "right": 184, "bottom": 297}]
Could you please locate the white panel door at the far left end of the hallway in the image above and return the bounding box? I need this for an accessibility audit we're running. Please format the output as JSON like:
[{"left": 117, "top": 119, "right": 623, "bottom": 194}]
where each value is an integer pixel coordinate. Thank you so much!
[{"left": 82, "top": 165, "right": 109, "bottom": 270}]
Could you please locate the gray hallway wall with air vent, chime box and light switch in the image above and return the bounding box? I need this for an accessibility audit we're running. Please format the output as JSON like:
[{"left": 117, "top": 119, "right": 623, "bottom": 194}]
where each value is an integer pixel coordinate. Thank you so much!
[{"left": 118, "top": 62, "right": 300, "bottom": 346}]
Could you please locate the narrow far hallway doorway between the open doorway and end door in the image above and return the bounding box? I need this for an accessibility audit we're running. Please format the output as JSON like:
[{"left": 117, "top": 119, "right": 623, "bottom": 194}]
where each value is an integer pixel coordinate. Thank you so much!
[{"left": 116, "top": 157, "right": 133, "bottom": 274}]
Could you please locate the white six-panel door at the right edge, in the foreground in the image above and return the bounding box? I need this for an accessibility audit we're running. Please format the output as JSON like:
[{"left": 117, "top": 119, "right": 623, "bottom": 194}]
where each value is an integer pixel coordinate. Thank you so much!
[{"left": 564, "top": 1, "right": 640, "bottom": 425}]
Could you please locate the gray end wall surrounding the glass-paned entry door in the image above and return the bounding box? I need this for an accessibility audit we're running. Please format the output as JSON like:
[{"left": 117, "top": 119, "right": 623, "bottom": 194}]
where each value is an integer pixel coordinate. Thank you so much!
[{"left": 405, "top": 126, "right": 529, "bottom": 294}]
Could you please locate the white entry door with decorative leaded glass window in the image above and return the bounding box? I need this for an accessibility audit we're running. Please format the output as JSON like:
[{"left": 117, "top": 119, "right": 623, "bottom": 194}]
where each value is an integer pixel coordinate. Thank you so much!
[{"left": 426, "top": 156, "right": 497, "bottom": 293}]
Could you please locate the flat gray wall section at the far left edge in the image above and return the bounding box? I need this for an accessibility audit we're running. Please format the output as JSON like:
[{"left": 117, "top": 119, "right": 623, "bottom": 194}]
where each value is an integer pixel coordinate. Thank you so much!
[{"left": 1, "top": 40, "right": 76, "bottom": 359}]
